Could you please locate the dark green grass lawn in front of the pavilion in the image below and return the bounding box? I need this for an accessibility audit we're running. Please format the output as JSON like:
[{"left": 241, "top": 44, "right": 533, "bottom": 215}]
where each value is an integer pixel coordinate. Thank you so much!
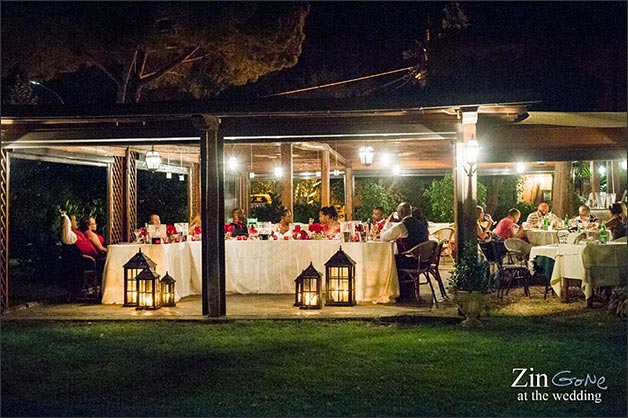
[{"left": 1, "top": 309, "right": 627, "bottom": 416}]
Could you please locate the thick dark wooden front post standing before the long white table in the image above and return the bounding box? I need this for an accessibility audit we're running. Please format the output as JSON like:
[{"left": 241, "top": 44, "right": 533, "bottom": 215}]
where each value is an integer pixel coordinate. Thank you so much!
[{"left": 196, "top": 117, "right": 227, "bottom": 318}]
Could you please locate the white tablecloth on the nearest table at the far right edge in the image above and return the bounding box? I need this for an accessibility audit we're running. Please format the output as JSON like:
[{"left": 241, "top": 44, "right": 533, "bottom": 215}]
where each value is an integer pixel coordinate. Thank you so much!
[{"left": 530, "top": 241, "right": 626, "bottom": 299}]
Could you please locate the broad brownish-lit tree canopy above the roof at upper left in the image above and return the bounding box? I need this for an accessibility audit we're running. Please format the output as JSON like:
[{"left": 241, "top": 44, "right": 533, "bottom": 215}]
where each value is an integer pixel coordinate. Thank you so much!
[{"left": 2, "top": 1, "right": 309, "bottom": 103}]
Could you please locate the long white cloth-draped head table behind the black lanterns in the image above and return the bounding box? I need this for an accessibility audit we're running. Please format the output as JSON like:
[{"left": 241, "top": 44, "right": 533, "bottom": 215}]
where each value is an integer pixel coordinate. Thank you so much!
[{"left": 102, "top": 240, "right": 399, "bottom": 304}]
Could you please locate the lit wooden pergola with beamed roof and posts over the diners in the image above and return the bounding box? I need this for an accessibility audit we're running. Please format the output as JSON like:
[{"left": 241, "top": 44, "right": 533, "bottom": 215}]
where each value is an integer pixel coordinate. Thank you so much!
[{"left": 0, "top": 100, "right": 626, "bottom": 317}]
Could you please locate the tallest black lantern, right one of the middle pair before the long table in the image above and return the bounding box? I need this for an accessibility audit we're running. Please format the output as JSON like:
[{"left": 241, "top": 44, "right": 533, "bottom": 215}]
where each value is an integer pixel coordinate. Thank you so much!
[{"left": 325, "top": 246, "right": 355, "bottom": 306}]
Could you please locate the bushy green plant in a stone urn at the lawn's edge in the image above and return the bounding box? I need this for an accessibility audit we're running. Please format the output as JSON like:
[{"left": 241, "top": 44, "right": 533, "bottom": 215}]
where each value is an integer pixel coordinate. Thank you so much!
[{"left": 449, "top": 241, "right": 491, "bottom": 326}]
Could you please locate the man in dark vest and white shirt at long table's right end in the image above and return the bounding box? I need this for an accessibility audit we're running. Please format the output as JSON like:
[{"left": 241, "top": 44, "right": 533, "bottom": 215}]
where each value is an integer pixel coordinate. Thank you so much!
[{"left": 381, "top": 202, "right": 429, "bottom": 270}]
